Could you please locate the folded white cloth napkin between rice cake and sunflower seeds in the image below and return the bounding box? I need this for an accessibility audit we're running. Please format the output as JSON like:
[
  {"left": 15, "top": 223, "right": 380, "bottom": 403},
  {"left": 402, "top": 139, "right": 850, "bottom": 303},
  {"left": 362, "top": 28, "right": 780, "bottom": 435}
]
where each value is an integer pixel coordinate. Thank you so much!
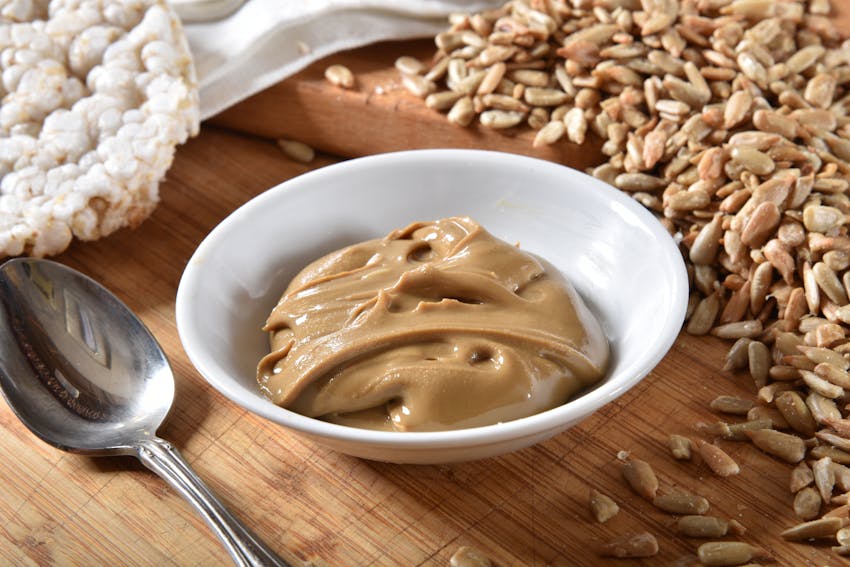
[{"left": 184, "top": 0, "right": 504, "bottom": 119}]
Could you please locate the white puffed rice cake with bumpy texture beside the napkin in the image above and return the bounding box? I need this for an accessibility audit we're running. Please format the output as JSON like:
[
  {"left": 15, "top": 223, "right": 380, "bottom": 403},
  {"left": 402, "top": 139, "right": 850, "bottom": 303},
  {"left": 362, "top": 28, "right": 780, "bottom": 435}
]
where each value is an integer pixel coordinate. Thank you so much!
[{"left": 0, "top": 0, "right": 200, "bottom": 258}]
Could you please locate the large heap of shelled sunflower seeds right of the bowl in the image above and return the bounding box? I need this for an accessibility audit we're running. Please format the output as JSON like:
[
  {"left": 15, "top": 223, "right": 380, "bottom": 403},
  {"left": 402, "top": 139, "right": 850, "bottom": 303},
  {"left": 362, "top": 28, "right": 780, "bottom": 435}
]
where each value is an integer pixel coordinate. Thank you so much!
[{"left": 396, "top": 0, "right": 850, "bottom": 555}]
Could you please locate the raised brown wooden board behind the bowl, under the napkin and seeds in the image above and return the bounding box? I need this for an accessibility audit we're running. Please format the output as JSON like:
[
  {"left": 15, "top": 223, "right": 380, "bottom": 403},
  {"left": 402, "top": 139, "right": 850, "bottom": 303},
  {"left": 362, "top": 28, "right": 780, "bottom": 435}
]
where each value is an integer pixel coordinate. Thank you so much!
[{"left": 211, "top": 40, "right": 601, "bottom": 170}]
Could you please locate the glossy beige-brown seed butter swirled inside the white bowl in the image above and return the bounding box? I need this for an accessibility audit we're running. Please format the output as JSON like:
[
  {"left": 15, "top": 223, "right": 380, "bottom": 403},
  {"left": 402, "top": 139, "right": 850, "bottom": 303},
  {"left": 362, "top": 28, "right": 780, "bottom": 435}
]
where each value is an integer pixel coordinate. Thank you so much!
[{"left": 257, "top": 217, "right": 608, "bottom": 431}]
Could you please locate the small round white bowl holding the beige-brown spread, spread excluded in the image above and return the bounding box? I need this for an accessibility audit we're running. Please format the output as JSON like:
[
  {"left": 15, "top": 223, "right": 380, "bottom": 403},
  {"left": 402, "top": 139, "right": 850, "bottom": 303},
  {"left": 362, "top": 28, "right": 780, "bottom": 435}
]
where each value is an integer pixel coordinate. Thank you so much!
[{"left": 176, "top": 150, "right": 688, "bottom": 463}]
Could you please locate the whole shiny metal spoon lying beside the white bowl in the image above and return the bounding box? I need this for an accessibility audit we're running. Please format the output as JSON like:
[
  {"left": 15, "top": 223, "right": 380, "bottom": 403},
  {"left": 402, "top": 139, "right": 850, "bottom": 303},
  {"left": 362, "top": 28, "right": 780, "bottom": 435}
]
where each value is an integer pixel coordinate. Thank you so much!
[{"left": 0, "top": 258, "right": 287, "bottom": 566}]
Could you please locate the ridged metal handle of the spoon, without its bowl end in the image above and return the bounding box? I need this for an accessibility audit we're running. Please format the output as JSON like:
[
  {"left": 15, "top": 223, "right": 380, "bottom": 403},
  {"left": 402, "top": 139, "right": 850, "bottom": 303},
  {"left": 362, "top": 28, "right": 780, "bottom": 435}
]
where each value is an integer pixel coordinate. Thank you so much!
[{"left": 134, "top": 437, "right": 289, "bottom": 567}]
